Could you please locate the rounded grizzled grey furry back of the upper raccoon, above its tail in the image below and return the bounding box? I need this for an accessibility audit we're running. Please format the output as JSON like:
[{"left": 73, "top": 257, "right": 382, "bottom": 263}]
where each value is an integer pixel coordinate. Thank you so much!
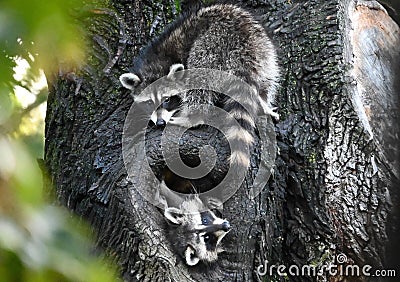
[{"left": 182, "top": 4, "right": 279, "bottom": 108}]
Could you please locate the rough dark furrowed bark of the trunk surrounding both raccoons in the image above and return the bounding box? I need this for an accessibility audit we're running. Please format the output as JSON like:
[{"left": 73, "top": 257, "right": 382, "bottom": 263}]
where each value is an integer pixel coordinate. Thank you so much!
[{"left": 45, "top": 0, "right": 400, "bottom": 281}]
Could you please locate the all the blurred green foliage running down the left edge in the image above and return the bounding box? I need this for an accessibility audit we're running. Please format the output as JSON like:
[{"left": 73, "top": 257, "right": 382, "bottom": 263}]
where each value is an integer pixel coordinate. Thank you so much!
[{"left": 0, "top": 0, "right": 116, "bottom": 281}]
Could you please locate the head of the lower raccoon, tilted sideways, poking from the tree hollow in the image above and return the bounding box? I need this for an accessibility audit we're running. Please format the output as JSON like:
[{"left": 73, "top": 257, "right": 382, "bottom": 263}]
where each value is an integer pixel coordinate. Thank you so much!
[{"left": 164, "top": 197, "right": 231, "bottom": 266}]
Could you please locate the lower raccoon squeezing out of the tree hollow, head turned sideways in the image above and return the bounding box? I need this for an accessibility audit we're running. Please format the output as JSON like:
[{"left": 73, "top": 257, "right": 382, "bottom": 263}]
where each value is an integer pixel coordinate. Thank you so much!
[{"left": 155, "top": 176, "right": 231, "bottom": 266}]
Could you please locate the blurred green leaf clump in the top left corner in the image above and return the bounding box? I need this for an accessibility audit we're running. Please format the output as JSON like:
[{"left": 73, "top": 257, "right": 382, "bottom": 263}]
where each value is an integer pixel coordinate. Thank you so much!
[{"left": 0, "top": 0, "right": 83, "bottom": 71}]
